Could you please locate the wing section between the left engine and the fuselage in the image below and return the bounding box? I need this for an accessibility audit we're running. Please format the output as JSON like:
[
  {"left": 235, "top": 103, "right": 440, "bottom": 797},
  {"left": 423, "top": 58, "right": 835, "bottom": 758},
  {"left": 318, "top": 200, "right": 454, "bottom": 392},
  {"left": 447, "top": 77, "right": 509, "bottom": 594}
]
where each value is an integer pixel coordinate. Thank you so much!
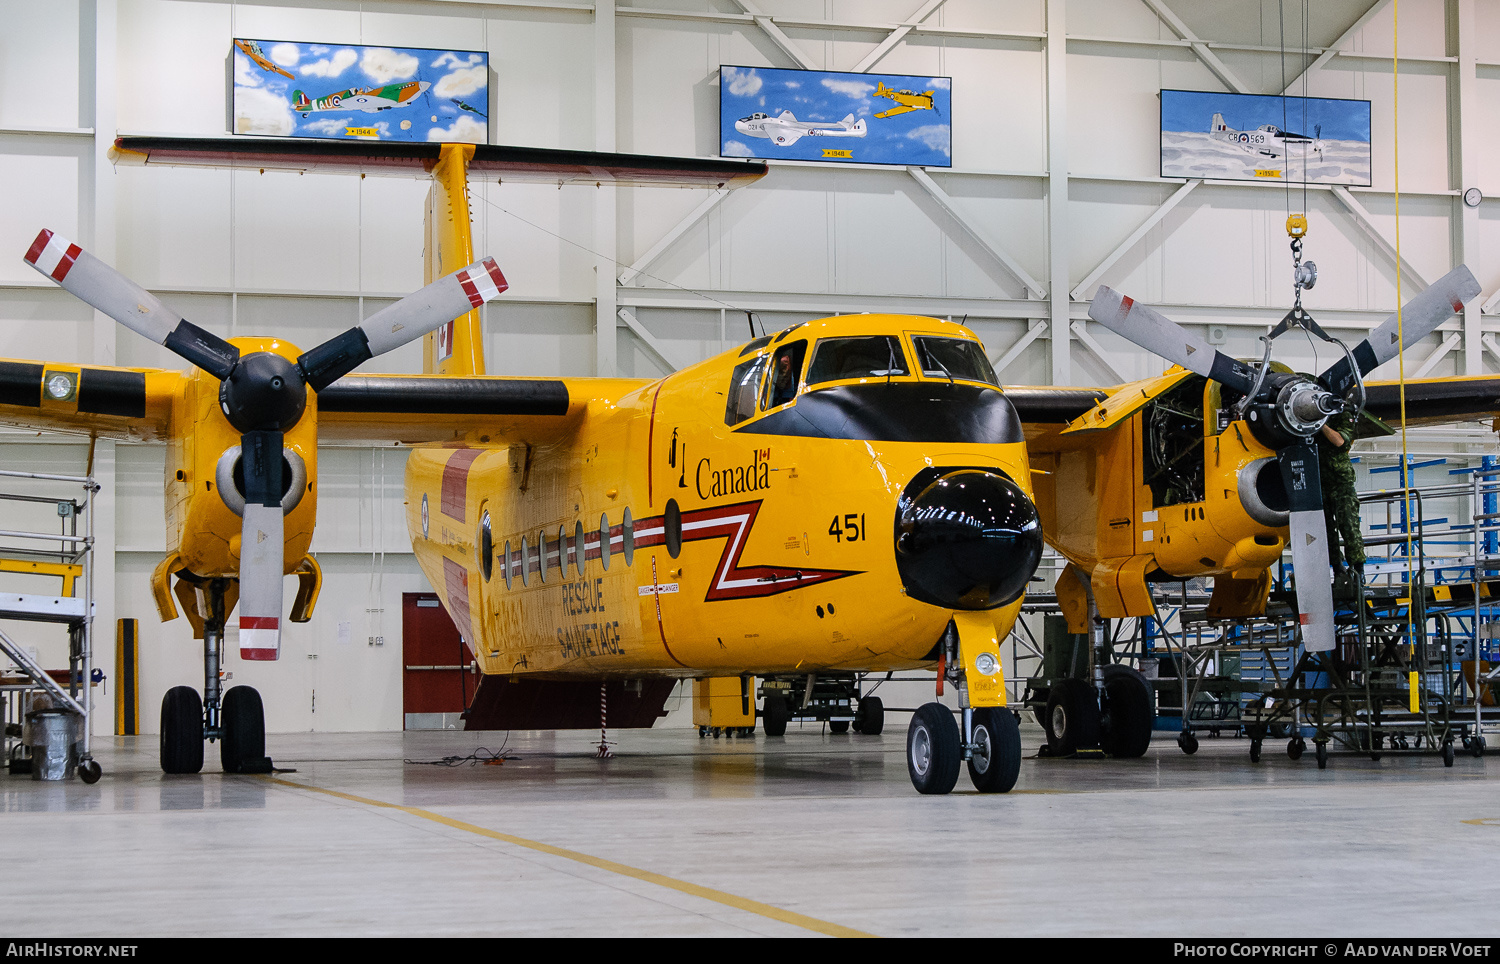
[{"left": 318, "top": 375, "right": 651, "bottom": 444}]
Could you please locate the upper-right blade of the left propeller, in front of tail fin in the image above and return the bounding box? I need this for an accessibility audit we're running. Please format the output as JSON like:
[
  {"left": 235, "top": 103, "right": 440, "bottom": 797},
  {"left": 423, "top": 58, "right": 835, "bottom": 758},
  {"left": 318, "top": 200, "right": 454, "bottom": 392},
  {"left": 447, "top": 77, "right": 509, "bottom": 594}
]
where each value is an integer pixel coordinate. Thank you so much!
[{"left": 297, "top": 258, "right": 510, "bottom": 391}]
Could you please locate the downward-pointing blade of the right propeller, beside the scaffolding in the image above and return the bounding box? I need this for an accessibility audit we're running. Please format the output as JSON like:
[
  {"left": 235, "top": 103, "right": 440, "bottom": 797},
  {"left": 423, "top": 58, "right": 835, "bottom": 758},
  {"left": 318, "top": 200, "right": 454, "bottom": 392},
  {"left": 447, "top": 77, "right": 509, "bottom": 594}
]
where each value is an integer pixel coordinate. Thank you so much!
[{"left": 1278, "top": 442, "right": 1334, "bottom": 652}]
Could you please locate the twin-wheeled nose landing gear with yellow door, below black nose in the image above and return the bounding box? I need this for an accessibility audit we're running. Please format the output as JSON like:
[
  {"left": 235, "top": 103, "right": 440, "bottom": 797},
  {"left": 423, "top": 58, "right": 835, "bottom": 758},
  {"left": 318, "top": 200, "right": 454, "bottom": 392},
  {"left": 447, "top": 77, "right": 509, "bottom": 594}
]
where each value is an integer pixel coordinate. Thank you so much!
[{"left": 906, "top": 618, "right": 1022, "bottom": 793}]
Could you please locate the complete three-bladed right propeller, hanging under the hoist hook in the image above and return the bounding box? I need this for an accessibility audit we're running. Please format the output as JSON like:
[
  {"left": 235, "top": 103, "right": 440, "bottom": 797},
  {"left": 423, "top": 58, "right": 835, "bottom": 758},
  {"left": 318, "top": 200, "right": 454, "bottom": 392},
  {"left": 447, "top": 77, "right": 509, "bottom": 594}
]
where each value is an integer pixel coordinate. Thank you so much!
[{"left": 1089, "top": 265, "right": 1479, "bottom": 652}]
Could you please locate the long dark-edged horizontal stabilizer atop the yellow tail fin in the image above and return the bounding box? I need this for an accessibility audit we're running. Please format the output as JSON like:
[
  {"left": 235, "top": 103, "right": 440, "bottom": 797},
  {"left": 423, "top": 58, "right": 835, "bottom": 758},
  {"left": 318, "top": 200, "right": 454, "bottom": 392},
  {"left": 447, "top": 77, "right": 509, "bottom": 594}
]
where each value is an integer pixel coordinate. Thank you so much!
[{"left": 110, "top": 136, "right": 767, "bottom": 187}]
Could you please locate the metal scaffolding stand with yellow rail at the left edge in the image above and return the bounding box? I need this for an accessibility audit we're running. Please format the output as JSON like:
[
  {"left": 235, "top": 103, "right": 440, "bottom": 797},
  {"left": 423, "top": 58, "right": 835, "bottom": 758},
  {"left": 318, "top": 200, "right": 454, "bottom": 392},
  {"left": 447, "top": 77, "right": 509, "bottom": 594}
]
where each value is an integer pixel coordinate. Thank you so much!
[{"left": 0, "top": 471, "right": 101, "bottom": 783}]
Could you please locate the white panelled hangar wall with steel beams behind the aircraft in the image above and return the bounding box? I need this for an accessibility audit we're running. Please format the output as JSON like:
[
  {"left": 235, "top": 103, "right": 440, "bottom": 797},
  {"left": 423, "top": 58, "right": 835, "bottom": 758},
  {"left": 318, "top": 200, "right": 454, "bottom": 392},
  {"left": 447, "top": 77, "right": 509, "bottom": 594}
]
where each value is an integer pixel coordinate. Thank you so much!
[{"left": 0, "top": 0, "right": 1500, "bottom": 732}]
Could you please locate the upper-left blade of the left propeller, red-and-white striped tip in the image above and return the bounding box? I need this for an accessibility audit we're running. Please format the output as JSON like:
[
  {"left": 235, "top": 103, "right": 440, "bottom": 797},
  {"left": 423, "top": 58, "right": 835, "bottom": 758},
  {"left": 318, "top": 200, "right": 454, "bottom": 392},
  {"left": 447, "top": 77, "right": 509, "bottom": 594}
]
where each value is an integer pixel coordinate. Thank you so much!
[{"left": 26, "top": 228, "right": 240, "bottom": 379}]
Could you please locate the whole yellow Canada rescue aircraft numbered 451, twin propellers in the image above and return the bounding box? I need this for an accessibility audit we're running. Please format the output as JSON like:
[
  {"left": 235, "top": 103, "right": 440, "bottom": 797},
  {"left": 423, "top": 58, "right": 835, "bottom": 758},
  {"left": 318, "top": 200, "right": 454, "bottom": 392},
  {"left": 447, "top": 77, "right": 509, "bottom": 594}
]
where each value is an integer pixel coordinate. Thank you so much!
[{"left": 11, "top": 138, "right": 1500, "bottom": 793}]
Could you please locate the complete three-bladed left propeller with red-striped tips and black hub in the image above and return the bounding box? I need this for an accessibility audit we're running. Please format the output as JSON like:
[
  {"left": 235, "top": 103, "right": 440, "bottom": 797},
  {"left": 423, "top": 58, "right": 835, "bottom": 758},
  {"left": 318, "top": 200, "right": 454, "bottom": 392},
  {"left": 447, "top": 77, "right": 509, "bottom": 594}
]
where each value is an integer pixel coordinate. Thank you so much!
[{"left": 26, "top": 229, "right": 509, "bottom": 660}]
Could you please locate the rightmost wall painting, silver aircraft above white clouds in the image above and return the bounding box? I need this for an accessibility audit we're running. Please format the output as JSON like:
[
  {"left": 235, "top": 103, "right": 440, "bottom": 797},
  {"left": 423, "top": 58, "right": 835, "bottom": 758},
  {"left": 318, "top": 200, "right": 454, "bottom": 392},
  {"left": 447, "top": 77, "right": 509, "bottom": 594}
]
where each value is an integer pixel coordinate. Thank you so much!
[{"left": 1161, "top": 90, "right": 1370, "bottom": 186}]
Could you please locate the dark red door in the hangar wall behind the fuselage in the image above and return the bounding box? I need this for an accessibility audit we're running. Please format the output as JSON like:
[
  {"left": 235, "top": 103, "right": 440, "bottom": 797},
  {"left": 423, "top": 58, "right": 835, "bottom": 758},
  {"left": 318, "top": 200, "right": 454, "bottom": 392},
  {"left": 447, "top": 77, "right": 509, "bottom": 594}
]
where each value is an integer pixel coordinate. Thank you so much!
[{"left": 401, "top": 592, "right": 476, "bottom": 730}]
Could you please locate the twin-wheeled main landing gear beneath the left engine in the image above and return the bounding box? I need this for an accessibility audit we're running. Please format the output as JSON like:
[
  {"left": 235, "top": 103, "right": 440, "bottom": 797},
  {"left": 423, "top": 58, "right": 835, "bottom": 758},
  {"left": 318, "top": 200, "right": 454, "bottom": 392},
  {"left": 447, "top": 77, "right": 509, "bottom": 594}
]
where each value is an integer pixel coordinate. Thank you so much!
[{"left": 161, "top": 579, "right": 272, "bottom": 774}]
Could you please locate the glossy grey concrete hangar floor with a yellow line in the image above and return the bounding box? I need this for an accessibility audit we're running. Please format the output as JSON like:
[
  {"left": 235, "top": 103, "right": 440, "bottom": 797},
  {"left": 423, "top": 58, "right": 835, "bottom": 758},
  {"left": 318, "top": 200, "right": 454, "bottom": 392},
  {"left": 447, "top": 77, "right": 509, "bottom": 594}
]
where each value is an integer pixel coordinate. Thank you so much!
[{"left": 0, "top": 725, "right": 1500, "bottom": 937}]
